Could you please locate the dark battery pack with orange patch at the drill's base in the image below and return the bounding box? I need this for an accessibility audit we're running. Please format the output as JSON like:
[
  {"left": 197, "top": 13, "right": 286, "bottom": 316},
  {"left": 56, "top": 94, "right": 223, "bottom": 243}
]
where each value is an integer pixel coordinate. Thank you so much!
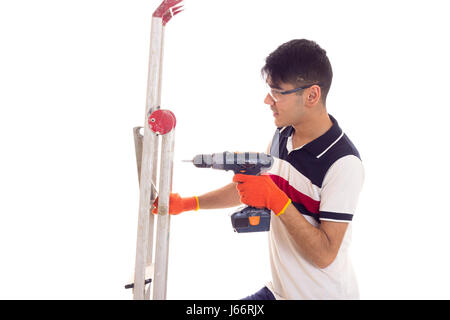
[{"left": 231, "top": 207, "right": 270, "bottom": 233}]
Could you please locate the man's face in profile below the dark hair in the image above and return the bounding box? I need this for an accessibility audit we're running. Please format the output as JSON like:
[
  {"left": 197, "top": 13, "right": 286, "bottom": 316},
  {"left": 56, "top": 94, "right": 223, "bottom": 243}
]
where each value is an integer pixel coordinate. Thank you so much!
[{"left": 264, "top": 79, "right": 306, "bottom": 127}]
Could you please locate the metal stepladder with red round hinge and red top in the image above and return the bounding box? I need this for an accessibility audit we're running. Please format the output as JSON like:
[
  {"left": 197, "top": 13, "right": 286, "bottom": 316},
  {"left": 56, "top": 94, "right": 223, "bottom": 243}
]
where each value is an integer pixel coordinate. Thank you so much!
[{"left": 128, "top": 0, "right": 182, "bottom": 300}]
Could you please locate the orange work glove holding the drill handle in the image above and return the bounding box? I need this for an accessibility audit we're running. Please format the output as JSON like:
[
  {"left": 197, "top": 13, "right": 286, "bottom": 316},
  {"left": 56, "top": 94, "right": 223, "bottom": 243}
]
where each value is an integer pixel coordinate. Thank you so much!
[{"left": 233, "top": 174, "right": 291, "bottom": 216}]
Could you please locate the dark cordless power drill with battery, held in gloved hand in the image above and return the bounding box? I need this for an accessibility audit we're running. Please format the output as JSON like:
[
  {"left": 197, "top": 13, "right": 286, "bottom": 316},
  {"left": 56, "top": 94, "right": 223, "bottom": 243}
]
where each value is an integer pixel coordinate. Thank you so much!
[{"left": 184, "top": 151, "right": 273, "bottom": 233}]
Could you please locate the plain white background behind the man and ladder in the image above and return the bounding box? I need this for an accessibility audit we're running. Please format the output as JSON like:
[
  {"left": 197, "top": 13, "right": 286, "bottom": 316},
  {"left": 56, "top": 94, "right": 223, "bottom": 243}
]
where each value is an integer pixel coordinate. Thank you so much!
[{"left": 0, "top": 0, "right": 450, "bottom": 299}]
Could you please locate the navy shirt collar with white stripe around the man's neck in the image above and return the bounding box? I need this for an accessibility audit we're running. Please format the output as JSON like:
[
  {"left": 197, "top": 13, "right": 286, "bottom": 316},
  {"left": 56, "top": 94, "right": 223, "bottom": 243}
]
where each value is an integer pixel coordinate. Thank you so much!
[{"left": 279, "top": 114, "right": 344, "bottom": 158}]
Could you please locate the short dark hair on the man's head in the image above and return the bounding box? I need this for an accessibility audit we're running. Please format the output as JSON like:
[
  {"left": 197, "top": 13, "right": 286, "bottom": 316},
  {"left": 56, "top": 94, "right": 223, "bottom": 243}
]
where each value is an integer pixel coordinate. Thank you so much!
[{"left": 261, "top": 39, "right": 333, "bottom": 104}]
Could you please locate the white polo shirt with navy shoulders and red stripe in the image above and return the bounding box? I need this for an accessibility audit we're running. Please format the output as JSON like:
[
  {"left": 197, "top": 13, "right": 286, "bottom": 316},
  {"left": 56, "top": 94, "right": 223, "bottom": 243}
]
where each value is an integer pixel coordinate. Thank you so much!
[{"left": 267, "top": 115, "right": 364, "bottom": 300}]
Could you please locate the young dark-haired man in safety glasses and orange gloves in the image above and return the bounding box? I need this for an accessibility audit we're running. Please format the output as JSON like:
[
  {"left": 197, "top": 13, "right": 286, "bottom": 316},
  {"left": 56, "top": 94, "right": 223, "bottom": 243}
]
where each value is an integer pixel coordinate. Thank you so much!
[{"left": 156, "top": 39, "right": 364, "bottom": 300}]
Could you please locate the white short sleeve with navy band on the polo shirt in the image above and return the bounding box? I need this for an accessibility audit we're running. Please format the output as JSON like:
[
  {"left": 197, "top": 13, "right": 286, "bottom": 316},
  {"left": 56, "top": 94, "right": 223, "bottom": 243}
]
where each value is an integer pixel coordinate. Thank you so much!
[{"left": 319, "top": 155, "right": 364, "bottom": 222}]
